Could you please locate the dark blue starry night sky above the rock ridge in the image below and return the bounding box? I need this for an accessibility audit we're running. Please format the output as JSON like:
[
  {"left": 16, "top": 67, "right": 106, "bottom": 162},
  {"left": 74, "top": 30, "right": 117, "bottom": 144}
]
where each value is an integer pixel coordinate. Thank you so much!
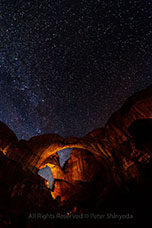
[{"left": 0, "top": 0, "right": 152, "bottom": 139}]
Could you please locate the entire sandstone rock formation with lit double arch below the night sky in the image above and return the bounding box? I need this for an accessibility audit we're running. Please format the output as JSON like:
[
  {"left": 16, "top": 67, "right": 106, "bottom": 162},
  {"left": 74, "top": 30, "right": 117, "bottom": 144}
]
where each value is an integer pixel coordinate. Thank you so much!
[{"left": 0, "top": 86, "right": 152, "bottom": 227}]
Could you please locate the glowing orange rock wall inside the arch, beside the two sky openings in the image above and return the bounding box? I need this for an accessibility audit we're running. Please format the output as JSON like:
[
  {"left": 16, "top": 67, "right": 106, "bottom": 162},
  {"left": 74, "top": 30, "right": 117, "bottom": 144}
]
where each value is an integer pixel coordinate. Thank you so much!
[{"left": 50, "top": 149, "right": 103, "bottom": 202}]
